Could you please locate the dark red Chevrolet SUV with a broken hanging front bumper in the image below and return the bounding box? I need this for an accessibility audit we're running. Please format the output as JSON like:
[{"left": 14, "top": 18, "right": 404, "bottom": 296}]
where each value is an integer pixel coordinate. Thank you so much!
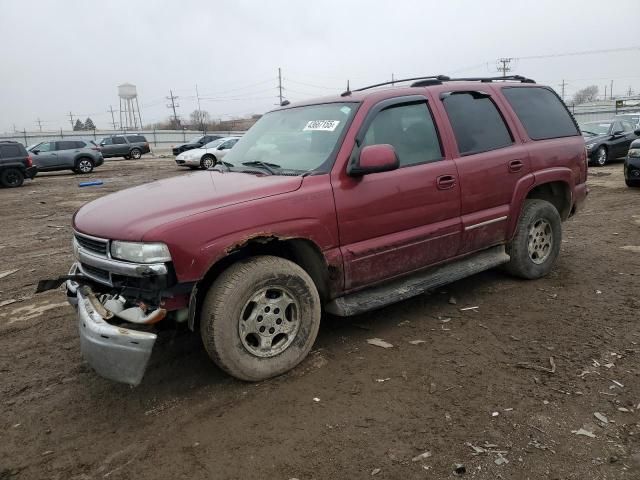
[{"left": 47, "top": 76, "right": 588, "bottom": 384}]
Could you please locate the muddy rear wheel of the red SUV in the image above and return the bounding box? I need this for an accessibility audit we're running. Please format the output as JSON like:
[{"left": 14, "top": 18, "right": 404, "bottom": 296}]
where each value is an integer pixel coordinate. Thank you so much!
[{"left": 505, "top": 200, "right": 562, "bottom": 279}]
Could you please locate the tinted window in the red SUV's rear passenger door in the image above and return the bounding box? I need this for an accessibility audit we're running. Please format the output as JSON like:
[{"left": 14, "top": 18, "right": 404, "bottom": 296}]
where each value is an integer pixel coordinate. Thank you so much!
[{"left": 443, "top": 92, "right": 513, "bottom": 155}]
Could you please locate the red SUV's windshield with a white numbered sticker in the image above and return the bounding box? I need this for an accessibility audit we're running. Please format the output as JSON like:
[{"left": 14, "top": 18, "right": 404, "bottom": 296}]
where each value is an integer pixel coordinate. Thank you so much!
[{"left": 224, "top": 103, "right": 356, "bottom": 173}]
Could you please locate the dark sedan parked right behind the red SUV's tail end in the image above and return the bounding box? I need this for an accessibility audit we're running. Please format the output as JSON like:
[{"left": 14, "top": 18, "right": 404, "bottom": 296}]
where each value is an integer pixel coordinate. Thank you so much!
[{"left": 580, "top": 120, "right": 637, "bottom": 167}]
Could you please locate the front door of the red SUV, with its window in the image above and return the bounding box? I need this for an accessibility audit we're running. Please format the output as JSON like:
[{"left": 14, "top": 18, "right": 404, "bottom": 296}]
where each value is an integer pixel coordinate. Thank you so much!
[{"left": 331, "top": 95, "right": 461, "bottom": 290}]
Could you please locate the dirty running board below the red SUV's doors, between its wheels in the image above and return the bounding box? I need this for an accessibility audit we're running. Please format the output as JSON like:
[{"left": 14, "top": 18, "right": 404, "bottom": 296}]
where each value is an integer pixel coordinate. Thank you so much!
[{"left": 325, "top": 245, "right": 510, "bottom": 317}]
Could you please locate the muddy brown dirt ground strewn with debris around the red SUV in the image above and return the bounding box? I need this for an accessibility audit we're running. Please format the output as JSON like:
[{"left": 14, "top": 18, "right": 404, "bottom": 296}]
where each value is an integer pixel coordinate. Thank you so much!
[{"left": 0, "top": 158, "right": 640, "bottom": 480}]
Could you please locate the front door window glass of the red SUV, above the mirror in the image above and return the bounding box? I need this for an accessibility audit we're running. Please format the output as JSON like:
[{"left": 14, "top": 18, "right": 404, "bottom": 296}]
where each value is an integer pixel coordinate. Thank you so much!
[{"left": 362, "top": 102, "right": 443, "bottom": 167}]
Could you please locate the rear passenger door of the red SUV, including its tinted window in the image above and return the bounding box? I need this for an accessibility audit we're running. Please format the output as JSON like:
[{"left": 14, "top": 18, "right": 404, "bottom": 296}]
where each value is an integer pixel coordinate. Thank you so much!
[{"left": 440, "top": 89, "right": 533, "bottom": 254}]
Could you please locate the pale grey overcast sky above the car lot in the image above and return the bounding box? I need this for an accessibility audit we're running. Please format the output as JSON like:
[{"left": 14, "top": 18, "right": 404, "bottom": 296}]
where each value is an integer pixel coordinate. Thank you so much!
[{"left": 0, "top": 0, "right": 640, "bottom": 131}]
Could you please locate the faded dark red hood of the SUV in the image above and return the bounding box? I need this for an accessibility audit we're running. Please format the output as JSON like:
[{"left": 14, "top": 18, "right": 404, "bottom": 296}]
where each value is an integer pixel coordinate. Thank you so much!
[{"left": 73, "top": 171, "right": 303, "bottom": 241}]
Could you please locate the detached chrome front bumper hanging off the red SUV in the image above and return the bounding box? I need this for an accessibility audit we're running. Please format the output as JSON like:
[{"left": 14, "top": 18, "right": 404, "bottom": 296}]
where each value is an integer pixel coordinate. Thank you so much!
[{"left": 66, "top": 270, "right": 157, "bottom": 385}]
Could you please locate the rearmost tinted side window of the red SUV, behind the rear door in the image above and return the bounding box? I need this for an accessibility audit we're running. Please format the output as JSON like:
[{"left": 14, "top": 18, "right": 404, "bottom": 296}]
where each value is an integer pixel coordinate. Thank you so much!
[{"left": 502, "top": 87, "right": 580, "bottom": 140}]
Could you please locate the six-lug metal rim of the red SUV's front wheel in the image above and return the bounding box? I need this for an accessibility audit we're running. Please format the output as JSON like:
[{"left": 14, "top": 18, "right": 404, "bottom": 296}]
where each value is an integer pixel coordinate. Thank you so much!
[{"left": 238, "top": 287, "right": 300, "bottom": 358}]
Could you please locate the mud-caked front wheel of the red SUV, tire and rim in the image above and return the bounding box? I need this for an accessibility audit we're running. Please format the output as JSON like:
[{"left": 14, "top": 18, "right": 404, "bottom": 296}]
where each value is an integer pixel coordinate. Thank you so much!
[{"left": 200, "top": 256, "right": 320, "bottom": 381}]
